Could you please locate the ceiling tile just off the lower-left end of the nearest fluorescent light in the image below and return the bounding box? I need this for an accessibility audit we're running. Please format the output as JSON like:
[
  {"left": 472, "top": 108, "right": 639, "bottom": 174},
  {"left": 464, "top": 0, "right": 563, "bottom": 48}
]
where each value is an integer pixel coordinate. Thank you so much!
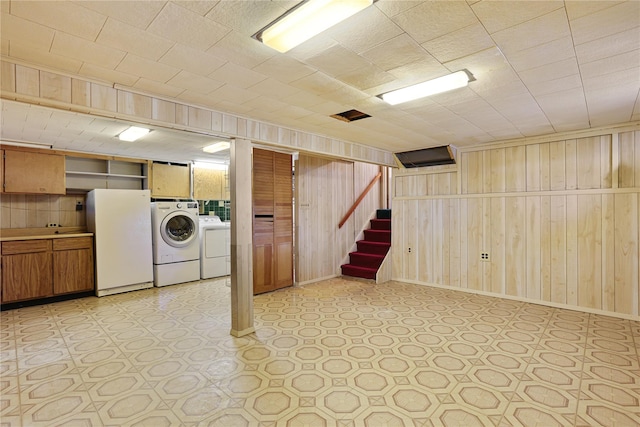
[{"left": 207, "top": 33, "right": 278, "bottom": 68}]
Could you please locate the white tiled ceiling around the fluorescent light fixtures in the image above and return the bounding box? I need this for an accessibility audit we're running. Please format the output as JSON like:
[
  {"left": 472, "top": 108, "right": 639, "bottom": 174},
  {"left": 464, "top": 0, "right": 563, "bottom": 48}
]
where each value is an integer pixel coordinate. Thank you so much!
[{"left": 1, "top": 0, "right": 640, "bottom": 163}]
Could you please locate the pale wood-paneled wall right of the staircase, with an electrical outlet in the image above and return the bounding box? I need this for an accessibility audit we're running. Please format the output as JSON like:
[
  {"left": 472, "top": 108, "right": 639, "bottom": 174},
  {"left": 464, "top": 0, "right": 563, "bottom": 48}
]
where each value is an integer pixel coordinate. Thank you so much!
[{"left": 392, "top": 131, "right": 640, "bottom": 317}]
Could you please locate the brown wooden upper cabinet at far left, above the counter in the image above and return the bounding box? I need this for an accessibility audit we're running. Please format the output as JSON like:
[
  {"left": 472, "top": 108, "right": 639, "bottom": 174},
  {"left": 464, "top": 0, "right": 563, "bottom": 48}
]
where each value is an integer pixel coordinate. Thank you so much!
[{"left": 4, "top": 149, "right": 66, "bottom": 194}]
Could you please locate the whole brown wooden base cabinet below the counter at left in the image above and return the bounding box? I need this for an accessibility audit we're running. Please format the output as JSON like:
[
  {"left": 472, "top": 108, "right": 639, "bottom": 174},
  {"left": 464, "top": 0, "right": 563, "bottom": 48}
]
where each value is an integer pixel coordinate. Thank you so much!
[{"left": 0, "top": 237, "right": 94, "bottom": 304}]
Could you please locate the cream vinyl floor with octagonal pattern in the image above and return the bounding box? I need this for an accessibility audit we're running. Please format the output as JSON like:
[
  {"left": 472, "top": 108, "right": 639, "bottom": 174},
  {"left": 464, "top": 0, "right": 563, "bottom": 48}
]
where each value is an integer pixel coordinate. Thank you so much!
[{"left": 0, "top": 278, "right": 640, "bottom": 427}]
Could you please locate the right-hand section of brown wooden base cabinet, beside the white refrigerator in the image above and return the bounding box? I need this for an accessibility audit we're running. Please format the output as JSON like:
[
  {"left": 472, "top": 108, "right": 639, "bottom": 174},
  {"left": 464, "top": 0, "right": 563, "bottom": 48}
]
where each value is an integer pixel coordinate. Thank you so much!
[{"left": 53, "top": 237, "right": 94, "bottom": 295}]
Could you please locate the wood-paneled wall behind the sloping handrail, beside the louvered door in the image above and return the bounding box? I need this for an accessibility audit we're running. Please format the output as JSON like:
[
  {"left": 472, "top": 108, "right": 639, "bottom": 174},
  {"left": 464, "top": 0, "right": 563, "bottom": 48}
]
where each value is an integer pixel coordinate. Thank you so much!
[{"left": 295, "top": 155, "right": 383, "bottom": 284}]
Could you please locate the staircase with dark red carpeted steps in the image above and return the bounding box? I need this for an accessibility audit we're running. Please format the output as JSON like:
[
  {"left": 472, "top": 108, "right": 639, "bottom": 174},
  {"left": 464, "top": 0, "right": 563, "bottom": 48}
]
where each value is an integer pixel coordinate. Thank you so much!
[{"left": 341, "top": 209, "right": 391, "bottom": 279}]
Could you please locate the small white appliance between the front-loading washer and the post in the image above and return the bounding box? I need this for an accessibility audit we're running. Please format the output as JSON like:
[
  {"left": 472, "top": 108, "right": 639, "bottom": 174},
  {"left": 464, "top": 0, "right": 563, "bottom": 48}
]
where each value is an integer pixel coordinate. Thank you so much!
[{"left": 200, "top": 216, "right": 231, "bottom": 279}]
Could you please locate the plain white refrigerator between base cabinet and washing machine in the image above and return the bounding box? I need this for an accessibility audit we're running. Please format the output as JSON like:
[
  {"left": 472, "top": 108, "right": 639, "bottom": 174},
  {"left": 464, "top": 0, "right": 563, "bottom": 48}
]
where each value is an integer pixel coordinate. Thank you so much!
[{"left": 87, "top": 189, "right": 153, "bottom": 297}]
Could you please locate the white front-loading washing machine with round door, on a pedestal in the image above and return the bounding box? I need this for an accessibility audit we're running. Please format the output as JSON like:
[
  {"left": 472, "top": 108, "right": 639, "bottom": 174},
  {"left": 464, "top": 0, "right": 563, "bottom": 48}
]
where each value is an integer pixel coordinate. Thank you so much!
[{"left": 151, "top": 201, "right": 200, "bottom": 287}]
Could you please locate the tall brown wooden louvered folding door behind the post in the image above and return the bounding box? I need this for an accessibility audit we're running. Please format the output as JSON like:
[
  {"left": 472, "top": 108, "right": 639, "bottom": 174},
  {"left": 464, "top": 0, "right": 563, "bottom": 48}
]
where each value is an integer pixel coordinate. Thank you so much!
[{"left": 253, "top": 149, "right": 293, "bottom": 295}]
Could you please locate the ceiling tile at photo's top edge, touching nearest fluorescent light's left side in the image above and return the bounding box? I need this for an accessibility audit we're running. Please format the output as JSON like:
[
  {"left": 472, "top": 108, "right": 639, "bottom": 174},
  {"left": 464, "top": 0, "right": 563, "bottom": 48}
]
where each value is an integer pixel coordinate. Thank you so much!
[{"left": 206, "top": 0, "right": 287, "bottom": 36}]
